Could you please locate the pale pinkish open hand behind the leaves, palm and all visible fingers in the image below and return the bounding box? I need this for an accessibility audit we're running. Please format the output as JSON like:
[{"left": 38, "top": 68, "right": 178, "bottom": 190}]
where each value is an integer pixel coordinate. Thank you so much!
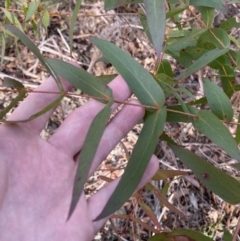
[{"left": 0, "top": 70, "right": 158, "bottom": 241}]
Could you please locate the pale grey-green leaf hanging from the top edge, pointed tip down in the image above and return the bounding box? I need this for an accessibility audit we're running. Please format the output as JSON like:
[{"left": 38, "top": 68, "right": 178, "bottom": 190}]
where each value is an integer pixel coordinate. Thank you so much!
[{"left": 143, "top": 0, "right": 166, "bottom": 60}]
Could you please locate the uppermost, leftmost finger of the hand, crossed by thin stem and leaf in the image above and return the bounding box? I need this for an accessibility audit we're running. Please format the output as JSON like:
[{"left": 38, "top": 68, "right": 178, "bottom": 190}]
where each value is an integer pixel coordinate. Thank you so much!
[{"left": 8, "top": 77, "right": 73, "bottom": 134}]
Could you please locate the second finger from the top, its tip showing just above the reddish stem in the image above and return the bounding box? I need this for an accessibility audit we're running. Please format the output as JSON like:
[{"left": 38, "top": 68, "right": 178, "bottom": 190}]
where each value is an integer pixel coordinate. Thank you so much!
[{"left": 48, "top": 76, "right": 131, "bottom": 156}]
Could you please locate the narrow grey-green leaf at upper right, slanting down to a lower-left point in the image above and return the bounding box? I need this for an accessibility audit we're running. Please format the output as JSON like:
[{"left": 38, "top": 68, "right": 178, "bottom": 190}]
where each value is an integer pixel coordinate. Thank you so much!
[{"left": 175, "top": 48, "right": 229, "bottom": 80}]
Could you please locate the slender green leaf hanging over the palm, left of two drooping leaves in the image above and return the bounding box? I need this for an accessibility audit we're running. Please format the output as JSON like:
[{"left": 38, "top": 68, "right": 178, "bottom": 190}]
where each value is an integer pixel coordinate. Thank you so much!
[{"left": 68, "top": 99, "right": 113, "bottom": 219}]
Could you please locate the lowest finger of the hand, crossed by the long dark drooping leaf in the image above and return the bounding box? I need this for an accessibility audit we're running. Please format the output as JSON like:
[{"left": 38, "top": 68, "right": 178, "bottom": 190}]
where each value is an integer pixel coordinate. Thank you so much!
[{"left": 87, "top": 156, "right": 159, "bottom": 232}]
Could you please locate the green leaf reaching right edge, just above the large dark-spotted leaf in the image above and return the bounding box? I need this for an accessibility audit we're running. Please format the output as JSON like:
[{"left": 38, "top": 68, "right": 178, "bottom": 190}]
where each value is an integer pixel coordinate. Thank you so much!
[{"left": 193, "top": 110, "right": 240, "bottom": 161}]
